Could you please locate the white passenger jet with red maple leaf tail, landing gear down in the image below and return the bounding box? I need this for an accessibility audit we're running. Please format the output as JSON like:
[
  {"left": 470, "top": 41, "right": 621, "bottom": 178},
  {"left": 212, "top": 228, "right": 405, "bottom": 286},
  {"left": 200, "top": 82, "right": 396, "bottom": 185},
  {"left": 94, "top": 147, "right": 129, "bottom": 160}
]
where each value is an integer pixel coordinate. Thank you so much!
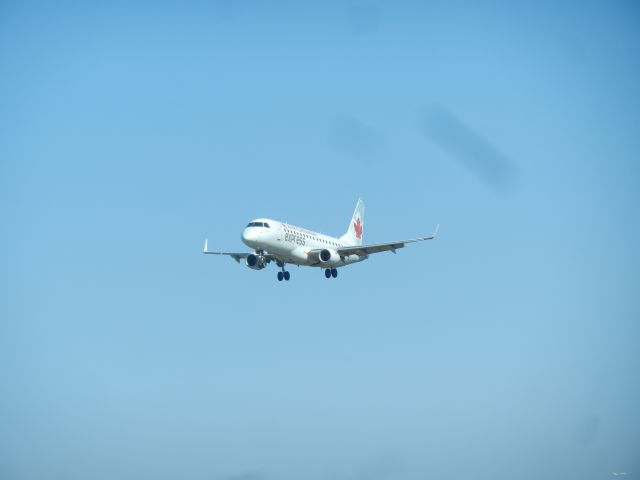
[{"left": 202, "top": 198, "right": 440, "bottom": 282}]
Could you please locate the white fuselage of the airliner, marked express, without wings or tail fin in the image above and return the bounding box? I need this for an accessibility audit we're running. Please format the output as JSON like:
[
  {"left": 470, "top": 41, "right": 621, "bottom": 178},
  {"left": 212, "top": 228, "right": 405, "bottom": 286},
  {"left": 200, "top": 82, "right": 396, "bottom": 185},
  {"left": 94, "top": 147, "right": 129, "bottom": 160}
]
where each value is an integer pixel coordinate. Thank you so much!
[{"left": 242, "top": 218, "right": 368, "bottom": 268}]
